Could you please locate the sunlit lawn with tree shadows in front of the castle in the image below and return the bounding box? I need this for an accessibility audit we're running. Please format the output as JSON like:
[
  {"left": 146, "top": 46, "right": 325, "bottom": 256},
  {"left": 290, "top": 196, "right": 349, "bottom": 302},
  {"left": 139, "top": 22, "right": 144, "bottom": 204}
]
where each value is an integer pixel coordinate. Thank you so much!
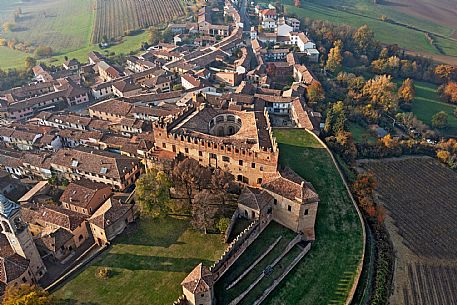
[{"left": 54, "top": 218, "right": 226, "bottom": 305}]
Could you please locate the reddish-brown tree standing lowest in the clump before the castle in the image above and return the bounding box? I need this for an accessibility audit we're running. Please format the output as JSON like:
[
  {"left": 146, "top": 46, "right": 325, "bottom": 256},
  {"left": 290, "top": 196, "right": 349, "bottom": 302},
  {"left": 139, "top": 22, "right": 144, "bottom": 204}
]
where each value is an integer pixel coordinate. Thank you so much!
[{"left": 191, "top": 189, "right": 218, "bottom": 234}]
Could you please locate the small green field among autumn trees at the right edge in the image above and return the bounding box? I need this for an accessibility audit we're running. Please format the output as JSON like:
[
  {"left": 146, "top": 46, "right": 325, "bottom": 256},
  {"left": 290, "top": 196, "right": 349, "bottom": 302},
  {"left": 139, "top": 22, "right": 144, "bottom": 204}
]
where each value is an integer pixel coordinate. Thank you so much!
[{"left": 412, "top": 81, "right": 457, "bottom": 135}]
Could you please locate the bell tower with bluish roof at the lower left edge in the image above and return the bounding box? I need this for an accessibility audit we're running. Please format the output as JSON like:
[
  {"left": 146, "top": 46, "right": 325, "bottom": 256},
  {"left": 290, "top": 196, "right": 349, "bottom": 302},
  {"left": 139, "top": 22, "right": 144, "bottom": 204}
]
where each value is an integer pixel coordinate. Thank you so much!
[{"left": 0, "top": 194, "right": 46, "bottom": 281}]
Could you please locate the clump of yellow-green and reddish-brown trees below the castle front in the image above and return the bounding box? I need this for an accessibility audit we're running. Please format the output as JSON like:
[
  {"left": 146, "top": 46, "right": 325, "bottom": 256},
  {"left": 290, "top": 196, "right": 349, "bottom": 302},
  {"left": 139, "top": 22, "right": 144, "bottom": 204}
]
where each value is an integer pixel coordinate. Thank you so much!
[{"left": 136, "top": 159, "right": 234, "bottom": 233}]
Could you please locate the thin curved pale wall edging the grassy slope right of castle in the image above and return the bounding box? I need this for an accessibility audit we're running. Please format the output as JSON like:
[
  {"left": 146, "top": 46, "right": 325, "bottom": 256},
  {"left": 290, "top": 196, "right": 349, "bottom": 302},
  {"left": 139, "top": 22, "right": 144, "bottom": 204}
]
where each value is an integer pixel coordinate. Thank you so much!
[{"left": 306, "top": 129, "right": 367, "bottom": 305}]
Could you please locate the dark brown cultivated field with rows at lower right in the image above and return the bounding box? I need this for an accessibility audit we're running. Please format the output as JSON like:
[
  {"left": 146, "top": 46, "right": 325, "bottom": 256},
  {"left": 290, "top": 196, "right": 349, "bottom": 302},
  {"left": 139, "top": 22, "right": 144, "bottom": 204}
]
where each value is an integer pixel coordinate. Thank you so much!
[{"left": 360, "top": 157, "right": 457, "bottom": 305}]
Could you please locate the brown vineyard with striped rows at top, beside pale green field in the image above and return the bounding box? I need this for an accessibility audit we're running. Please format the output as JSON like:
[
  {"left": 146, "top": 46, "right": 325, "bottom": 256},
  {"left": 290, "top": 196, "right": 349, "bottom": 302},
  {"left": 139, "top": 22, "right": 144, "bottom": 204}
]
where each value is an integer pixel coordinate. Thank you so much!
[{"left": 92, "top": 0, "right": 184, "bottom": 43}]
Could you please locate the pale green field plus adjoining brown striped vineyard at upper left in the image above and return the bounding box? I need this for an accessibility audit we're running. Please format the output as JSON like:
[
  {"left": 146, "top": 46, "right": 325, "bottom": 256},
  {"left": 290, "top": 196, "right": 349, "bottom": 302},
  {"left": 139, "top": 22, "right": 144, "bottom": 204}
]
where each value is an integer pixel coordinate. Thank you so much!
[{"left": 0, "top": 0, "right": 184, "bottom": 69}]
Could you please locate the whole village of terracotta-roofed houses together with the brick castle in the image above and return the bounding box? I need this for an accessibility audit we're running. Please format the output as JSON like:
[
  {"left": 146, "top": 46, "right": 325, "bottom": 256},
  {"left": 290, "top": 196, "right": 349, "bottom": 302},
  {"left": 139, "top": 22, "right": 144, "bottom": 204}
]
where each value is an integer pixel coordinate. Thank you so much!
[{"left": 0, "top": 0, "right": 321, "bottom": 305}]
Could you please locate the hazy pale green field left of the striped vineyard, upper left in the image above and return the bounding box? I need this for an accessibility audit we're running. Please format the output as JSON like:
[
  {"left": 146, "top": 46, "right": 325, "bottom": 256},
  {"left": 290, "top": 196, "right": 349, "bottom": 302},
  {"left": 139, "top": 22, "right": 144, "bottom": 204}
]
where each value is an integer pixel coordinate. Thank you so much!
[{"left": 0, "top": 0, "right": 147, "bottom": 69}]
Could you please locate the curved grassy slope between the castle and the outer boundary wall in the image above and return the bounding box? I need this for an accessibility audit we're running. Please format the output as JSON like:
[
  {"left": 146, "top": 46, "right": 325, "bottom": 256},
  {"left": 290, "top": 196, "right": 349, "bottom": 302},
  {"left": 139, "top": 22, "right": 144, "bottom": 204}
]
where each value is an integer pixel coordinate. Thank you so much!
[{"left": 265, "top": 129, "right": 363, "bottom": 305}]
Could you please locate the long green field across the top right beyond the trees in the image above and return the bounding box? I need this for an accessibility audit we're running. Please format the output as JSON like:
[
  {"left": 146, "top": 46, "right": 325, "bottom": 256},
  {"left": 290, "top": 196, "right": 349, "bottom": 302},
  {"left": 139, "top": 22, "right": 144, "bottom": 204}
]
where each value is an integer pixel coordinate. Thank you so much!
[{"left": 283, "top": 0, "right": 457, "bottom": 56}]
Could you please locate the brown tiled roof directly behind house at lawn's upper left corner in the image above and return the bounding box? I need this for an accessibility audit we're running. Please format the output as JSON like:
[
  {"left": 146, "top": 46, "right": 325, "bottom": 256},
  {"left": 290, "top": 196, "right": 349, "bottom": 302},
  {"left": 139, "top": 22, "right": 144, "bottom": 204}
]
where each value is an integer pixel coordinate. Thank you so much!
[{"left": 60, "top": 179, "right": 110, "bottom": 208}]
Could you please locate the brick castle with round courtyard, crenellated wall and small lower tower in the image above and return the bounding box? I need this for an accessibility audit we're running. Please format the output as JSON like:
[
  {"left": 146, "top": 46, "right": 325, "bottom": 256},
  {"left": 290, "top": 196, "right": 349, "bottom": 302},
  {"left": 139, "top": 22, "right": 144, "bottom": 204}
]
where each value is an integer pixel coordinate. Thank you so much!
[{"left": 153, "top": 94, "right": 319, "bottom": 305}]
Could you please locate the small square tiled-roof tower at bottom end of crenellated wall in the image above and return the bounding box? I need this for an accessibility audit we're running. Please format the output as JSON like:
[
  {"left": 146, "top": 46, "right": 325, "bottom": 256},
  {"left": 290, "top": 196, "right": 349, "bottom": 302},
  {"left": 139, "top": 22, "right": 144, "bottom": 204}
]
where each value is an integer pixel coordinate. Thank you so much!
[{"left": 181, "top": 263, "right": 214, "bottom": 305}]
